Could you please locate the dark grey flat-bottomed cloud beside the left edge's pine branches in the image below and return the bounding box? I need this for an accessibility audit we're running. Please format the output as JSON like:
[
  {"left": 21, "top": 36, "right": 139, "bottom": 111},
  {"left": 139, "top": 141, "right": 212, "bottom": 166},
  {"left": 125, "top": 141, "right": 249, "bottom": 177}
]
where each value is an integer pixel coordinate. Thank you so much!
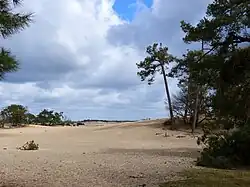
[{"left": 6, "top": 45, "right": 77, "bottom": 82}]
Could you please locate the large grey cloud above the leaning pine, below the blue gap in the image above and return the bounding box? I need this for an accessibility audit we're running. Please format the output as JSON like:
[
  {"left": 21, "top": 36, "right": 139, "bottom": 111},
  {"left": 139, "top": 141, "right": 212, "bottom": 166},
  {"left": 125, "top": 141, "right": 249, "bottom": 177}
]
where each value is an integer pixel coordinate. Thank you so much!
[{"left": 108, "top": 0, "right": 209, "bottom": 50}]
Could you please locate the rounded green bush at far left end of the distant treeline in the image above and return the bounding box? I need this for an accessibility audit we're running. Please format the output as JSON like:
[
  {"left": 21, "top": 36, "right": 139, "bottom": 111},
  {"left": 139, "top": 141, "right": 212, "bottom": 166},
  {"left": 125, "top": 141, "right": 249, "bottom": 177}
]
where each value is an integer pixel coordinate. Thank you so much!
[{"left": 0, "top": 104, "right": 28, "bottom": 125}]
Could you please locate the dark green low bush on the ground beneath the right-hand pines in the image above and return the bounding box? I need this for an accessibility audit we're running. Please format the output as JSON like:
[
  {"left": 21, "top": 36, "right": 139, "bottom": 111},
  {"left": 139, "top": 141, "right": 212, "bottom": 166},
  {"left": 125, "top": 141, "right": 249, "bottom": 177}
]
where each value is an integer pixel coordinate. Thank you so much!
[{"left": 197, "top": 125, "right": 250, "bottom": 169}]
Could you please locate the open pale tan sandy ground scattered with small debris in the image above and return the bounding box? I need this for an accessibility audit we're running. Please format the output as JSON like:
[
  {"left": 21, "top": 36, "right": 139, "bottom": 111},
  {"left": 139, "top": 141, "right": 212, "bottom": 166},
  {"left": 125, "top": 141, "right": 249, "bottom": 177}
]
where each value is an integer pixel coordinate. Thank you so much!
[{"left": 0, "top": 121, "right": 200, "bottom": 187}]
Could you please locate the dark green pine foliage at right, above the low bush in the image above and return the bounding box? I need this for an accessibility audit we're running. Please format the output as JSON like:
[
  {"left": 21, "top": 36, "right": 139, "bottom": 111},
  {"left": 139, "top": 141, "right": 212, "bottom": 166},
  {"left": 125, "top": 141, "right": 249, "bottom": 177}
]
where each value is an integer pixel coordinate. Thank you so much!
[{"left": 176, "top": 0, "right": 250, "bottom": 127}]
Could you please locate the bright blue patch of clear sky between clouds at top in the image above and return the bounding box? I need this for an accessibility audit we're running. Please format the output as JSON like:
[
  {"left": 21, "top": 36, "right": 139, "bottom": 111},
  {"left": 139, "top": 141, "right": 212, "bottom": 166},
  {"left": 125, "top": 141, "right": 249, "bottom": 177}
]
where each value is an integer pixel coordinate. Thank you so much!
[{"left": 113, "top": 0, "right": 153, "bottom": 21}]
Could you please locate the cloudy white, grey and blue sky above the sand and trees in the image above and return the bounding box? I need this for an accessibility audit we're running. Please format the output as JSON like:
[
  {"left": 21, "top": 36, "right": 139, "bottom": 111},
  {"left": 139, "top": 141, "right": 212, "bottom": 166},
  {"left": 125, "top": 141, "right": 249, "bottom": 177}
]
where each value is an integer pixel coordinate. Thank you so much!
[{"left": 0, "top": 0, "right": 210, "bottom": 120}]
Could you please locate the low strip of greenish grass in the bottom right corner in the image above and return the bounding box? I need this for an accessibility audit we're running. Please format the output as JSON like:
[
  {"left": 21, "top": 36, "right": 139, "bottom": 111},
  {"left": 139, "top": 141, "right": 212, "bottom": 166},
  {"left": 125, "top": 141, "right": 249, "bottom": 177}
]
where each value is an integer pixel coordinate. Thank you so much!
[{"left": 160, "top": 169, "right": 250, "bottom": 187}]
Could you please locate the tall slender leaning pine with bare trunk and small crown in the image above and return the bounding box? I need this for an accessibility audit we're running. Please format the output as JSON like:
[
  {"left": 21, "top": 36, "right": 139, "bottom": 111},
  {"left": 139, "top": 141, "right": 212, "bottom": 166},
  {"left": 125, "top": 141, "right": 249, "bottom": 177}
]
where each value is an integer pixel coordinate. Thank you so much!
[{"left": 136, "top": 43, "right": 174, "bottom": 125}]
